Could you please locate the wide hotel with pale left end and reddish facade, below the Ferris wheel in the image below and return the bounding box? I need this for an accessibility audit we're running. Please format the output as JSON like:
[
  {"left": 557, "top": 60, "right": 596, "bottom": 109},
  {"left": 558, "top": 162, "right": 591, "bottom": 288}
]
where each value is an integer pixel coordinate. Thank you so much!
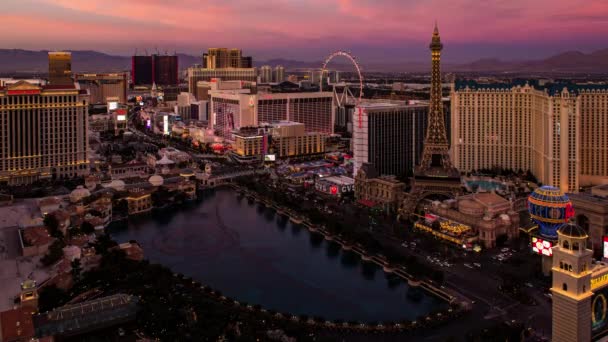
[{"left": 210, "top": 90, "right": 335, "bottom": 139}]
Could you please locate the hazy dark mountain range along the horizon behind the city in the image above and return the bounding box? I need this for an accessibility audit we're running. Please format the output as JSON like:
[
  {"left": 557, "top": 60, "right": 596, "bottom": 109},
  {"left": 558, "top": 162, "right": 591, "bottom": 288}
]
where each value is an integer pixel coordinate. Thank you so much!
[{"left": 0, "top": 49, "right": 608, "bottom": 74}]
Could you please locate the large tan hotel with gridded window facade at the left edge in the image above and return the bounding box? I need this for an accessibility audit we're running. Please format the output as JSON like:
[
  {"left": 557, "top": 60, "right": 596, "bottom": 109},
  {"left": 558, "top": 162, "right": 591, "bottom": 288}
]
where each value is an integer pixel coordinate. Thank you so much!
[{"left": 0, "top": 81, "right": 89, "bottom": 185}]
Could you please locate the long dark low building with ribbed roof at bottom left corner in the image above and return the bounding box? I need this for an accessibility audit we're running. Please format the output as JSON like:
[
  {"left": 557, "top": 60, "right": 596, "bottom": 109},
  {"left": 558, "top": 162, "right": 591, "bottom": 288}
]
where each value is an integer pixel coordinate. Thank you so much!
[{"left": 33, "top": 293, "right": 138, "bottom": 338}]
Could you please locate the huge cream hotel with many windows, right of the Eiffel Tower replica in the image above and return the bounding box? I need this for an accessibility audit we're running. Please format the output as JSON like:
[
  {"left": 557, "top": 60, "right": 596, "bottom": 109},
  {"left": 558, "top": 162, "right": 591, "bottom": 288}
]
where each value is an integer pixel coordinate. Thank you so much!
[{"left": 451, "top": 81, "right": 608, "bottom": 192}]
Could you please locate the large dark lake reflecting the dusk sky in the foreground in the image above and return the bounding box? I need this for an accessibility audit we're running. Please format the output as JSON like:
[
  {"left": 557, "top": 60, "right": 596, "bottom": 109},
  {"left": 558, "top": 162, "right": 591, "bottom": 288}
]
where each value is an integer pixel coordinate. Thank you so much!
[{"left": 110, "top": 189, "right": 445, "bottom": 321}]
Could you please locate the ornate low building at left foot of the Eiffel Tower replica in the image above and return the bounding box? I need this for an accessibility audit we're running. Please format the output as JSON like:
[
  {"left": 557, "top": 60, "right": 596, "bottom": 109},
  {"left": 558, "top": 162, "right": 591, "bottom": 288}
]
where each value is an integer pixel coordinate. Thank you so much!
[{"left": 355, "top": 163, "right": 405, "bottom": 213}]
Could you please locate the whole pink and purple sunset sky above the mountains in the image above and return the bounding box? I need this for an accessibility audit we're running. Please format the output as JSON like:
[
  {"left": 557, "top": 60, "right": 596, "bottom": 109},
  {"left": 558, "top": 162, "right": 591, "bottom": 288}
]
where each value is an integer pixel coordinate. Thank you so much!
[{"left": 0, "top": 0, "right": 608, "bottom": 62}]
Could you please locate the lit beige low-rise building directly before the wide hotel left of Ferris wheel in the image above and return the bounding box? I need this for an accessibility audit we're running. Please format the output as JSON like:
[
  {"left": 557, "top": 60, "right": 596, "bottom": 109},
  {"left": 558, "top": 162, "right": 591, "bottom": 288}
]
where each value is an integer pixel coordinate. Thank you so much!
[{"left": 232, "top": 121, "right": 326, "bottom": 161}]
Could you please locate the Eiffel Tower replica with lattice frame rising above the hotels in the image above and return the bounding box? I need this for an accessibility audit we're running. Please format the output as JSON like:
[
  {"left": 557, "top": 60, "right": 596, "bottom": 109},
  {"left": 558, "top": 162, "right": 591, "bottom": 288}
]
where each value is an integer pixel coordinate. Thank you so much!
[{"left": 399, "top": 23, "right": 462, "bottom": 218}]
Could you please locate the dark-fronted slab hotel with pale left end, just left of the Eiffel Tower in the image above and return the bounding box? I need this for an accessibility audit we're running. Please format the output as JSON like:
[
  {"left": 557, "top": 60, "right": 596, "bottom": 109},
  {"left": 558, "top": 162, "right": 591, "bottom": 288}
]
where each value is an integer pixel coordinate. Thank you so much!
[{"left": 352, "top": 102, "right": 428, "bottom": 176}]
